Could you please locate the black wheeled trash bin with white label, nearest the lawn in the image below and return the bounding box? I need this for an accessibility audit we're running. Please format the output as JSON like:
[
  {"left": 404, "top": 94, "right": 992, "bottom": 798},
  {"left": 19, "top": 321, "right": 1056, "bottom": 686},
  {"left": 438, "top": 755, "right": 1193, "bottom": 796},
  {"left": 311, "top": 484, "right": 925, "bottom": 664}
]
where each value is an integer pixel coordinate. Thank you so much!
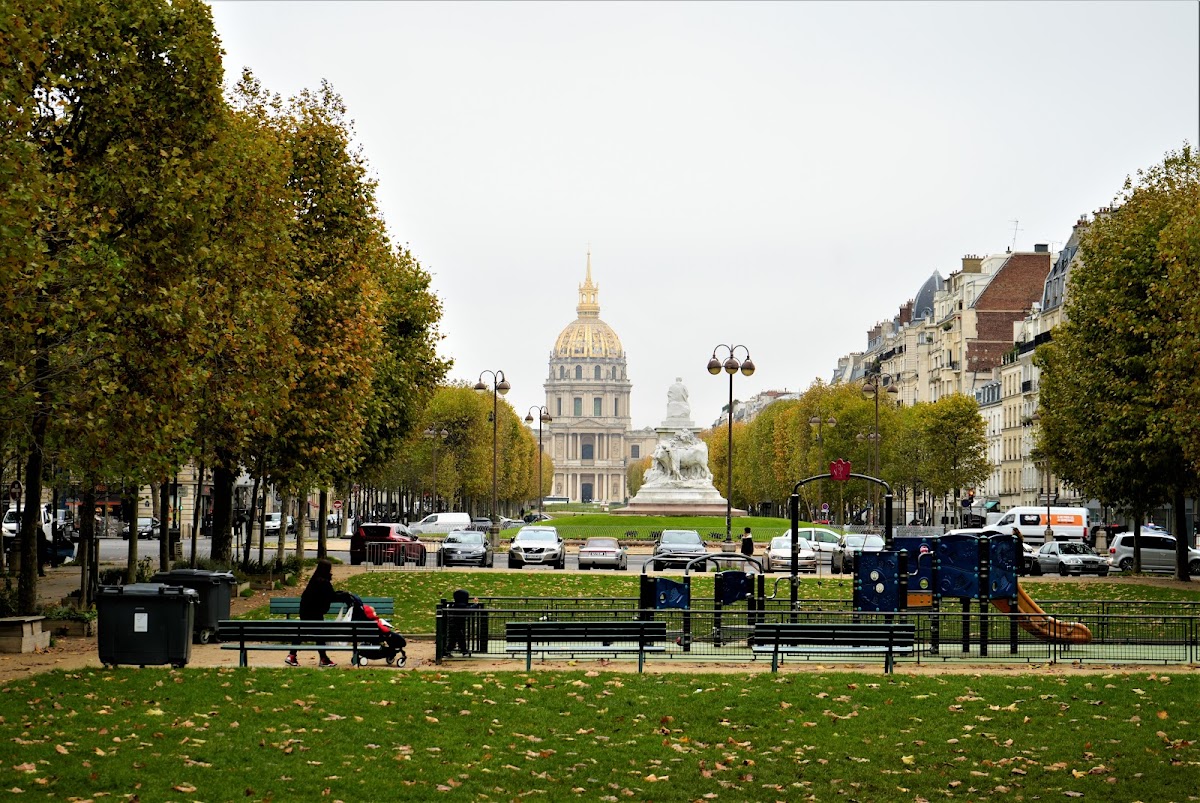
[{"left": 96, "top": 583, "right": 199, "bottom": 669}]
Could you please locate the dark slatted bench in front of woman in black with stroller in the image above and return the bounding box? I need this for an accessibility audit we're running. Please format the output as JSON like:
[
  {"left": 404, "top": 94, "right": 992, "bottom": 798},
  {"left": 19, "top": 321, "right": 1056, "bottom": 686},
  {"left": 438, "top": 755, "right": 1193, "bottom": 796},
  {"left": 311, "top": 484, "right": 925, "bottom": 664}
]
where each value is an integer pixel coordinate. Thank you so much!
[{"left": 217, "top": 619, "right": 379, "bottom": 666}]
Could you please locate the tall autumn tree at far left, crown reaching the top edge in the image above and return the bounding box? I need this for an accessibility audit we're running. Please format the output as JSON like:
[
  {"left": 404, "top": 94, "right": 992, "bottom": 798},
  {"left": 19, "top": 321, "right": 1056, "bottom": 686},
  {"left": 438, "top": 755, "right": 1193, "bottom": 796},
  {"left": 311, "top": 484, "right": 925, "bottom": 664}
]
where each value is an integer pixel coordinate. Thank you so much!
[{"left": 2, "top": 0, "right": 221, "bottom": 611}]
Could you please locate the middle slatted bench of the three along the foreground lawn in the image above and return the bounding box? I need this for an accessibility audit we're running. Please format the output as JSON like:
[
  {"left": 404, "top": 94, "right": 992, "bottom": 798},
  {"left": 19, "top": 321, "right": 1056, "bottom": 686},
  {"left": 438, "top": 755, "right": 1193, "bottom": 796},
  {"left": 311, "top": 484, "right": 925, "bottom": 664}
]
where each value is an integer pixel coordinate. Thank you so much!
[{"left": 504, "top": 619, "right": 667, "bottom": 672}]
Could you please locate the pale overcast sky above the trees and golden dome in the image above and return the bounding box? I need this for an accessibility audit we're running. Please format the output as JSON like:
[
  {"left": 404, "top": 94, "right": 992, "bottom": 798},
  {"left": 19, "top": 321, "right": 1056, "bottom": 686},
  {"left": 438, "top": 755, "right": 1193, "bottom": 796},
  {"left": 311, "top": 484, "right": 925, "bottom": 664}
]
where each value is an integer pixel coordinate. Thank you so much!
[{"left": 212, "top": 0, "right": 1200, "bottom": 426}]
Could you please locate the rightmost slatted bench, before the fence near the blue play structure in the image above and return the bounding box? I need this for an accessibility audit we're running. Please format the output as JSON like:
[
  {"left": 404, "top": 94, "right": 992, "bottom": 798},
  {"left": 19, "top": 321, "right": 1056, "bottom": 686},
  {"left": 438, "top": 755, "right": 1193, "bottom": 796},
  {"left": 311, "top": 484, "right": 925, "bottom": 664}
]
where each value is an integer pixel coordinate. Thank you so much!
[{"left": 751, "top": 622, "right": 917, "bottom": 673}]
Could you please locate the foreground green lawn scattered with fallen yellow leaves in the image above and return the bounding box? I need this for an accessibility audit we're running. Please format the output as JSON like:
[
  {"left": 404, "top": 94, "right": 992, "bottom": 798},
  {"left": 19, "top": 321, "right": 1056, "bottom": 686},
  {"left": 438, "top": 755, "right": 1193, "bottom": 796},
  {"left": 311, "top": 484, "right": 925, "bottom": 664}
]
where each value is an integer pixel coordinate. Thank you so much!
[{"left": 0, "top": 667, "right": 1200, "bottom": 802}]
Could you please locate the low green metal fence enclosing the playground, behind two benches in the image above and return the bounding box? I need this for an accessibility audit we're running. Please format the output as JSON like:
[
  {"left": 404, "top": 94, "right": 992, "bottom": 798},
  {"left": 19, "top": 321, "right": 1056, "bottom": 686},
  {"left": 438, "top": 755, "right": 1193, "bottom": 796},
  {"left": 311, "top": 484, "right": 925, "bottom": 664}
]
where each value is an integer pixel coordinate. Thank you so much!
[{"left": 436, "top": 598, "right": 1200, "bottom": 665}]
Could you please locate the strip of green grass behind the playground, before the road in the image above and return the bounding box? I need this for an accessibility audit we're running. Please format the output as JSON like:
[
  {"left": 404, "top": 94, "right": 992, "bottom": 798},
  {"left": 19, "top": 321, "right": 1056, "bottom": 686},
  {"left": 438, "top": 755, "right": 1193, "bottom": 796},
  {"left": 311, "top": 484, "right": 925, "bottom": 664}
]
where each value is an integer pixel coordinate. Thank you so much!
[{"left": 245, "top": 571, "right": 1196, "bottom": 634}]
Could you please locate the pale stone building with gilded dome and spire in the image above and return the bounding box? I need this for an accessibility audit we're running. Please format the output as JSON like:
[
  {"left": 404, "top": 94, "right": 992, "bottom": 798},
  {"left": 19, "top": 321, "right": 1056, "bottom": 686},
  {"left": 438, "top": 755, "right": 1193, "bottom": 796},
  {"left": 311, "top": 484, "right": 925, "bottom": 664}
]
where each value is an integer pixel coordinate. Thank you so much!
[{"left": 545, "top": 252, "right": 644, "bottom": 503}]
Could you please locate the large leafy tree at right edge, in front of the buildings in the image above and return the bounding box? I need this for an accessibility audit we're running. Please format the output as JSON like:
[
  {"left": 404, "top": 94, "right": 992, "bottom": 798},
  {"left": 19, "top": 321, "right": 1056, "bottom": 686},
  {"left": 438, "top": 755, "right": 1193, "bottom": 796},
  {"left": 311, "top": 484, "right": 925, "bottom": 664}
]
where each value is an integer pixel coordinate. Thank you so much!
[{"left": 1037, "top": 146, "right": 1200, "bottom": 579}]
